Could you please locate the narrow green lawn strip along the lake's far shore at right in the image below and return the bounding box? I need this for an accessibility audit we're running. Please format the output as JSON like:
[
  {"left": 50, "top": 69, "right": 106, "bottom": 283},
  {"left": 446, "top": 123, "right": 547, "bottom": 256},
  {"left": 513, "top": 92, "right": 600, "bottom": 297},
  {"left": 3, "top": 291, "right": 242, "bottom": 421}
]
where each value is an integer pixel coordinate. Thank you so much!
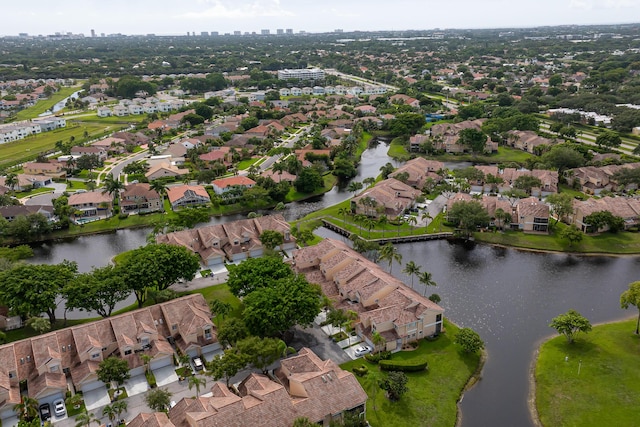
[{"left": 474, "top": 226, "right": 640, "bottom": 254}]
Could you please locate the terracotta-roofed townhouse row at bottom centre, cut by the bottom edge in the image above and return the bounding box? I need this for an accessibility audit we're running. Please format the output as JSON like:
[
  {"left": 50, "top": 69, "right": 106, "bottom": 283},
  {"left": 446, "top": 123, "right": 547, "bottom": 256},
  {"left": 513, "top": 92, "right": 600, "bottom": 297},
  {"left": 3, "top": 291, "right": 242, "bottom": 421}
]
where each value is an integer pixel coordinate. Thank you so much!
[{"left": 164, "top": 348, "right": 367, "bottom": 427}]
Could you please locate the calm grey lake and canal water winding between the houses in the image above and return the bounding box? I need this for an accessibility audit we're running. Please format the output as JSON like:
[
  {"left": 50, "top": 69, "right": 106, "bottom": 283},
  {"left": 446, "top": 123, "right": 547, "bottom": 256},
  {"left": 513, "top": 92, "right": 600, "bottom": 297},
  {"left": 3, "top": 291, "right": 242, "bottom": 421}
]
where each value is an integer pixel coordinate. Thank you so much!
[{"left": 30, "top": 144, "right": 640, "bottom": 427}]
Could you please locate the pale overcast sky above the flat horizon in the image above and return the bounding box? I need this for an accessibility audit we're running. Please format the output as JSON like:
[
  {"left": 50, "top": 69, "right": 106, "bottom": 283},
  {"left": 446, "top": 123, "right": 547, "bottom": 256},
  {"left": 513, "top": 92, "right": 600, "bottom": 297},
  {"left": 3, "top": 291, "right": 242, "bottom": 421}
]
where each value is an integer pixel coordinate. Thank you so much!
[{"left": 0, "top": 0, "right": 640, "bottom": 35}]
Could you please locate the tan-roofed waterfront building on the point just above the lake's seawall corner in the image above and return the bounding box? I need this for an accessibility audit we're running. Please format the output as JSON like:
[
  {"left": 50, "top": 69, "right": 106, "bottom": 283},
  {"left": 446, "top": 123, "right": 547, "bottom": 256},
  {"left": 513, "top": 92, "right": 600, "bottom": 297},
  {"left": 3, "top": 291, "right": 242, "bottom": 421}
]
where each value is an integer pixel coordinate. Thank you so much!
[{"left": 351, "top": 178, "right": 421, "bottom": 218}]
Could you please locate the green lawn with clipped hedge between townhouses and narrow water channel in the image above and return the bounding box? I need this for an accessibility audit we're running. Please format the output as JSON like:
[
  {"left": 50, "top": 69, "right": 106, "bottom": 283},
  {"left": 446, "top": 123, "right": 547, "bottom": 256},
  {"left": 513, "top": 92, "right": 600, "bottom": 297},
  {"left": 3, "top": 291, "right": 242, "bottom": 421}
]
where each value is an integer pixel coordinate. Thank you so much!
[{"left": 341, "top": 320, "right": 480, "bottom": 427}]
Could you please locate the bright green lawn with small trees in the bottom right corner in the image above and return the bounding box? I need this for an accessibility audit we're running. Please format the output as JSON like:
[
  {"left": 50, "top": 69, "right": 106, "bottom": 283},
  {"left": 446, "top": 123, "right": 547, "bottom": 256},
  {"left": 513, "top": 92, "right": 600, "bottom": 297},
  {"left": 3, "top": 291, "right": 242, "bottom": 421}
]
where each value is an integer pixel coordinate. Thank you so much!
[{"left": 535, "top": 319, "right": 640, "bottom": 427}]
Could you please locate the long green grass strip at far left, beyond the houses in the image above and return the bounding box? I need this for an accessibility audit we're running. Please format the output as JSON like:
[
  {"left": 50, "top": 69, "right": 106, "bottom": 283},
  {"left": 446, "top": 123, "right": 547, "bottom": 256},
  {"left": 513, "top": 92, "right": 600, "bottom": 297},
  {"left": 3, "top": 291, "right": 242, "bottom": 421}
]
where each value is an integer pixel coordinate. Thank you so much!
[{"left": 0, "top": 124, "right": 117, "bottom": 167}]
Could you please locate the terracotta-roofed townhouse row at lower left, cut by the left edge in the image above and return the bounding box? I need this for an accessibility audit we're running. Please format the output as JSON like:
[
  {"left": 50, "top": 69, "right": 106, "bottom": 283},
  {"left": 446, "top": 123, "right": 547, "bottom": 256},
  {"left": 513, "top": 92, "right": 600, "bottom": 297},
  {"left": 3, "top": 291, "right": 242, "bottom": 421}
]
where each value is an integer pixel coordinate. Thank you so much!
[{"left": 0, "top": 294, "right": 220, "bottom": 421}]
